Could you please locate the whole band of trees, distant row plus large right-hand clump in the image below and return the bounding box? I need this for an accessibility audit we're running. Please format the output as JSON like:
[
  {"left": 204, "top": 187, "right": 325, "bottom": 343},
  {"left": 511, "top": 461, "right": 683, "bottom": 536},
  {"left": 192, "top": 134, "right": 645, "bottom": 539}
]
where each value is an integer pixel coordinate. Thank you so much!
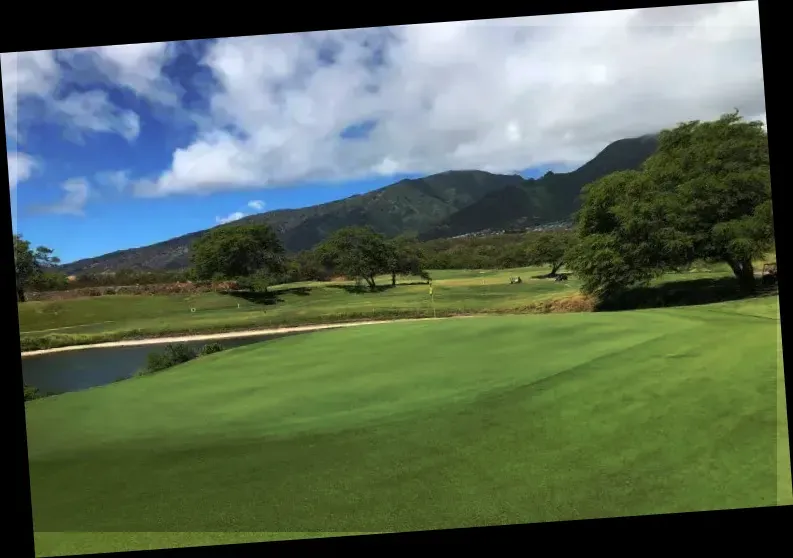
[{"left": 14, "top": 111, "right": 774, "bottom": 301}]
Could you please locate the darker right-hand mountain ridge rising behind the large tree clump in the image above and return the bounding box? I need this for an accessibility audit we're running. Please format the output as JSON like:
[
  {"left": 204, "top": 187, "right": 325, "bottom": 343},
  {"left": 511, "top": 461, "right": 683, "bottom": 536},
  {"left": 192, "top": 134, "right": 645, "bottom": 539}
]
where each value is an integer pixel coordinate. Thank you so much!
[{"left": 419, "top": 136, "right": 658, "bottom": 240}]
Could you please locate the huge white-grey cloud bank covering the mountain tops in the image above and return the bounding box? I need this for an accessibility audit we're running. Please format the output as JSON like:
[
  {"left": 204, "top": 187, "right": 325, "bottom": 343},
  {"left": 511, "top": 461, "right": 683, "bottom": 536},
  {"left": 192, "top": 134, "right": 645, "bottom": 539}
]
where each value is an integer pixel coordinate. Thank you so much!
[{"left": 137, "top": 2, "right": 765, "bottom": 195}]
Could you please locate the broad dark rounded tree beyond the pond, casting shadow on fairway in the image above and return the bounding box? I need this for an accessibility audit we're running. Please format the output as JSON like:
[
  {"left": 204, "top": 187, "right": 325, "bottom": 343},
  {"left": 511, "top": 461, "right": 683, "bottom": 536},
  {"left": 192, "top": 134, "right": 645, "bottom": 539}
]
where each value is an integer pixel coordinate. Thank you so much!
[{"left": 190, "top": 224, "right": 284, "bottom": 280}]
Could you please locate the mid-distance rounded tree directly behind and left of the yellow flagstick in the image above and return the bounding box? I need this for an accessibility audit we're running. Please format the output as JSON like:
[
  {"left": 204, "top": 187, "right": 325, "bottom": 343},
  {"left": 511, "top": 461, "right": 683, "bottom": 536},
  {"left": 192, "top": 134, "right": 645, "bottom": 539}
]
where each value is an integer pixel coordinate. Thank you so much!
[{"left": 316, "top": 227, "right": 391, "bottom": 290}]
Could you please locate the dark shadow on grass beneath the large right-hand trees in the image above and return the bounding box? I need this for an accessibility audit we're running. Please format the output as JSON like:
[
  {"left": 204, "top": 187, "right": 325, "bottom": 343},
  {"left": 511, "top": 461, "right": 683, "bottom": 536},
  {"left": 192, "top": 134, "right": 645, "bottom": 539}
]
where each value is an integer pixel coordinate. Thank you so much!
[{"left": 596, "top": 277, "right": 779, "bottom": 312}]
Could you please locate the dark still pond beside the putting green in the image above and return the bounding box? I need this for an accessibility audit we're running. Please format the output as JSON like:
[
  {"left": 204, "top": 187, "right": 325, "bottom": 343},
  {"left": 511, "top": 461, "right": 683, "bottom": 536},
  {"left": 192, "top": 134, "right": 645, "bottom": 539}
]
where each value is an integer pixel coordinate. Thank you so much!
[{"left": 22, "top": 332, "right": 307, "bottom": 394}]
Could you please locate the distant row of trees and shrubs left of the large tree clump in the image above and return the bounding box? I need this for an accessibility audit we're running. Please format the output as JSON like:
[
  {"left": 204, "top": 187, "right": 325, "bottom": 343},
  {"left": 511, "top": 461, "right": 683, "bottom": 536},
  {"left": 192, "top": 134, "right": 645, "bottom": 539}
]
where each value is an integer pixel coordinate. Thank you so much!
[{"left": 14, "top": 224, "right": 573, "bottom": 302}]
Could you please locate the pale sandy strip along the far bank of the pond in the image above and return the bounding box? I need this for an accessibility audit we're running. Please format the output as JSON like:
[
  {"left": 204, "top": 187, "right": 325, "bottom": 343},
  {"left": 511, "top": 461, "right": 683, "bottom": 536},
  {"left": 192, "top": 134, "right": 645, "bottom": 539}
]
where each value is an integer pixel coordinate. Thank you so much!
[{"left": 22, "top": 316, "right": 481, "bottom": 357}]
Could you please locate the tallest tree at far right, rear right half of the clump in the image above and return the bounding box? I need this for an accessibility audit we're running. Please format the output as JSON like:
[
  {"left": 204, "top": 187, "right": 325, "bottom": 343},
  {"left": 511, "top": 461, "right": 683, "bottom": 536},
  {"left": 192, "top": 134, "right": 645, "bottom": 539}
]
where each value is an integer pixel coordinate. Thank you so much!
[{"left": 644, "top": 110, "right": 774, "bottom": 290}]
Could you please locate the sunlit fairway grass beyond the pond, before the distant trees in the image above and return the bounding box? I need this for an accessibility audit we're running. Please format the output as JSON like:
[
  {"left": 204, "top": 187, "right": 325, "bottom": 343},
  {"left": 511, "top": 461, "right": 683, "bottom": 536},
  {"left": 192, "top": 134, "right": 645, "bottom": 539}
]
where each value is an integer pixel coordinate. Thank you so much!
[{"left": 19, "top": 268, "right": 577, "bottom": 350}]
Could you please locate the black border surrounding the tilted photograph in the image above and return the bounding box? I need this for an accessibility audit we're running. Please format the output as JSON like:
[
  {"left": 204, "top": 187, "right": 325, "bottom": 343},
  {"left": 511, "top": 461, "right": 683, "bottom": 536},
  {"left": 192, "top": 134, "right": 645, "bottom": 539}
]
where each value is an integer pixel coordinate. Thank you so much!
[{"left": 0, "top": 0, "right": 793, "bottom": 556}]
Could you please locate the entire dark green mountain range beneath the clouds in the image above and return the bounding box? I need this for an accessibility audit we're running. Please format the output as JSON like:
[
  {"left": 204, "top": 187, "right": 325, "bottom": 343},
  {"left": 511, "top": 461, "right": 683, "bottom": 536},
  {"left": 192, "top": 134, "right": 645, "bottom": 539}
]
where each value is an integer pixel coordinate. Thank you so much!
[{"left": 61, "top": 135, "right": 657, "bottom": 275}]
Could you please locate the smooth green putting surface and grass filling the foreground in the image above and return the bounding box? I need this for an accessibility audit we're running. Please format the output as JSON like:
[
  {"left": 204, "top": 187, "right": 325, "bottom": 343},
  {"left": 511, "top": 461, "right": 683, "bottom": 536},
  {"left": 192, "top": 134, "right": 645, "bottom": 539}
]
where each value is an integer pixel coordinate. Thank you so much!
[{"left": 26, "top": 297, "right": 789, "bottom": 555}]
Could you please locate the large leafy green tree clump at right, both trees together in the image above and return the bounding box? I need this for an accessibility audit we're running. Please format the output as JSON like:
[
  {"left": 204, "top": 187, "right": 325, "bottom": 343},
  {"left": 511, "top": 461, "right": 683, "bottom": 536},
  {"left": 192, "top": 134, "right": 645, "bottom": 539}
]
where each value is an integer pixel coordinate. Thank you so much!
[{"left": 568, "top": 112, "right": 774, "bottom": 298}]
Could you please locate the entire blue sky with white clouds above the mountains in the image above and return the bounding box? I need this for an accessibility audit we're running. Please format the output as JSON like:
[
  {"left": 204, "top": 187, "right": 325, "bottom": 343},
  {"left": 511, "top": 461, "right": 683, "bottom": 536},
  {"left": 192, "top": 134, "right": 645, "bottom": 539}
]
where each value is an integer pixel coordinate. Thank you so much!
[{"left": 0, "top": 1, "right": 765, "bottom": 262}]
